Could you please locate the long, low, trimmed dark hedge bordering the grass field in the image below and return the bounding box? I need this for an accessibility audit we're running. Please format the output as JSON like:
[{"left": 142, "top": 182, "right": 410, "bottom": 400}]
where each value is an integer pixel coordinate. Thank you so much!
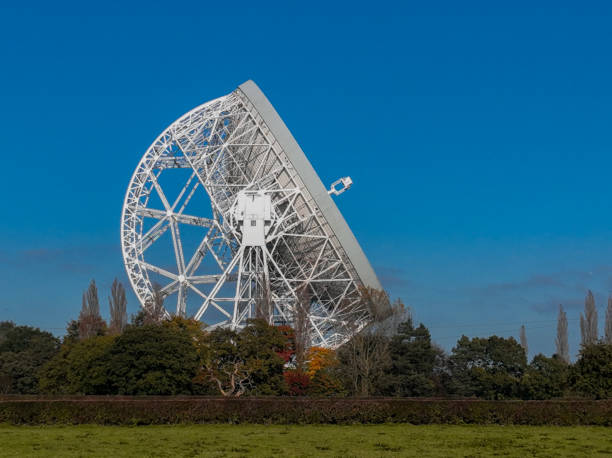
[{"left": 0, "top": 396, "right": 612, "bottom": 426}]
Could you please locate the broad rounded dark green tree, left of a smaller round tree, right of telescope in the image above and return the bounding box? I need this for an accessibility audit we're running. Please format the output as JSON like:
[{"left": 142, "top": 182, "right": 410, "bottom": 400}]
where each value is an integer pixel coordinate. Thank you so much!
[{"left": 449, "top": 336, "right": 527, "bottom": 399}]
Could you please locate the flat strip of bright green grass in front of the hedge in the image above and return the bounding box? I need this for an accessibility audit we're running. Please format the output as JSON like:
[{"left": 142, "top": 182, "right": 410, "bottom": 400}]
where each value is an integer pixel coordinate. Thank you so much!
[{"left": 0, "top": 424, "right": 612, "bottom": 457}]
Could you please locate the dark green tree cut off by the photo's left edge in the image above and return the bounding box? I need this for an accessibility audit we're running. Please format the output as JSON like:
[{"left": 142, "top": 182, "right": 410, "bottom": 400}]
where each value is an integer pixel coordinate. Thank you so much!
[{"left": 0, "top": 322, "right": 59, "bottom": 394}]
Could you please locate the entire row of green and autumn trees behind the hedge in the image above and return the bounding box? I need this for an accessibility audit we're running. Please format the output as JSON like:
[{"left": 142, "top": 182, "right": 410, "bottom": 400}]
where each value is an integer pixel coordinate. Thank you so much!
[{"left": 0, "top": 281, "right": 612, "bottom": 399}]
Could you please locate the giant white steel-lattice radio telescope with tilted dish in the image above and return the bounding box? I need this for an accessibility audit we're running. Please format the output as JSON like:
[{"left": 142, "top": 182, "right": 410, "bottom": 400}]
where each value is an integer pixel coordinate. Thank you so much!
[{"left": 121, "top": 81, "right": 380, "bottom": 348}]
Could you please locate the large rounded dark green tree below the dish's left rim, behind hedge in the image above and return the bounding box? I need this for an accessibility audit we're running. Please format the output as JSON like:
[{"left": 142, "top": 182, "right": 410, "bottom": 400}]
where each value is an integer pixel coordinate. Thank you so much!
[{"left": 108, "top": 325, "right": 199, "bottom": 395}]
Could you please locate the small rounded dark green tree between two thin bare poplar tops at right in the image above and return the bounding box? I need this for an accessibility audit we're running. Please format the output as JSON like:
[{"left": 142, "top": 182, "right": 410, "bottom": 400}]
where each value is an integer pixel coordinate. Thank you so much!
[{"left": 521, "top": 353, "right": 569, "bottom": 399}]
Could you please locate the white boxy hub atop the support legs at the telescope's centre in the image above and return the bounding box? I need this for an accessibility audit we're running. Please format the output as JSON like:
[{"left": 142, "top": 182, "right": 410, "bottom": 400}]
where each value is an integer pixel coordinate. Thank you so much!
[{"left": 233, "top": 191, "right": 272, "bottom": 247}]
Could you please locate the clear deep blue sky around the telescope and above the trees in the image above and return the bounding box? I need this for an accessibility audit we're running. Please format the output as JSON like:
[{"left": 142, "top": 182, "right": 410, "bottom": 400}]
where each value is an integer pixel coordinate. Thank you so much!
[{"left": 0, "top": 1, "right": 612, "bottom": 355}]
